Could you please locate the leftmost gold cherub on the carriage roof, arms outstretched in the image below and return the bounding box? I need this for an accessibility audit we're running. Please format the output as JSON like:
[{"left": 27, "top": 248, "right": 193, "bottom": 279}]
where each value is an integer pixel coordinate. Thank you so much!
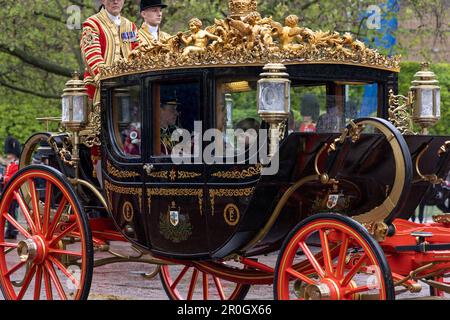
[{"left": 177, "top": 18, "right": 223, "bottom": 56}]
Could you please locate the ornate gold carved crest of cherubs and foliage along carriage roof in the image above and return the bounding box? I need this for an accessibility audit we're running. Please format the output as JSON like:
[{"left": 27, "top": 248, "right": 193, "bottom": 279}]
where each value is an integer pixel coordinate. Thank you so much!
[{"left": 101, "top": 11, "right": 400, "bottom": 79}]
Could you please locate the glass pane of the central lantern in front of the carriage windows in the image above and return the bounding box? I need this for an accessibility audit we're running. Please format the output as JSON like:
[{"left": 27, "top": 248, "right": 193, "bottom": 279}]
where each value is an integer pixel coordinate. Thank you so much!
[{"left": 258, "top": 81, "right": 288, "bottom": 113}]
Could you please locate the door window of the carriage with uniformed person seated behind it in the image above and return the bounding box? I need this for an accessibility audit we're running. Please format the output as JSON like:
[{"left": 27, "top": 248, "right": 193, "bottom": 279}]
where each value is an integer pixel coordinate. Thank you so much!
[{"left": 153, "top": 80, "right": 201, "bottom": 157}]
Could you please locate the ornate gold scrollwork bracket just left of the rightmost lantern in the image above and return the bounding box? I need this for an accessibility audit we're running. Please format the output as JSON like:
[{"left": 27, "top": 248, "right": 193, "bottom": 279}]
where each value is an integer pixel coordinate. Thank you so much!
[{"left": 388, "top": 89, "right": 415, "bottom": 134}]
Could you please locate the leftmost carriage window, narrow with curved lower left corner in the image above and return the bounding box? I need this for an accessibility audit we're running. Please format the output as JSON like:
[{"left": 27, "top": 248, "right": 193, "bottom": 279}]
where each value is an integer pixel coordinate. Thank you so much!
[{"left": 112, "top": 85, "right": 142, "bottom": 157}]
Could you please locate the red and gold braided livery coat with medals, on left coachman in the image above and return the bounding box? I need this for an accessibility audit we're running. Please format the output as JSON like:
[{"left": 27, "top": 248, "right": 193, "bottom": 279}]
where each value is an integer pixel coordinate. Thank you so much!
[{"left": 81, "top": 9, "right": 139, "bottom": 101}]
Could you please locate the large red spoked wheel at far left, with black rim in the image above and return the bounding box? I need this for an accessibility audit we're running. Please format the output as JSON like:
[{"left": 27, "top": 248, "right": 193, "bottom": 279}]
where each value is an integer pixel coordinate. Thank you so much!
[{"left": 0, "top": 166, "right": 93, "bottom": 300}]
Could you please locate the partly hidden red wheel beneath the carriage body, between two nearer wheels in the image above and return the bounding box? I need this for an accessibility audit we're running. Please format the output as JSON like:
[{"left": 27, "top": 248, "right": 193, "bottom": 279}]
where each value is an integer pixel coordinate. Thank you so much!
[{"left": 160, "top": 265, "right": 250, "bottom": 300}]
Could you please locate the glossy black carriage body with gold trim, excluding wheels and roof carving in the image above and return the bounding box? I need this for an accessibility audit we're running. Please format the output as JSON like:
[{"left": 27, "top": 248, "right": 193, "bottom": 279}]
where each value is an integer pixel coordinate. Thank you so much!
[{"left": 101, "top": 64, "right": 448, "bottom": 260}]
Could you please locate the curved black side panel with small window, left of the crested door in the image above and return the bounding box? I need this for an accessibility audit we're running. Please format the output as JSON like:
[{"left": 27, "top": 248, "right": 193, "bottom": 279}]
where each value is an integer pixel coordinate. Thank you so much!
[{"left": 102, "top": 77, "right": 147, "bottom": 245}]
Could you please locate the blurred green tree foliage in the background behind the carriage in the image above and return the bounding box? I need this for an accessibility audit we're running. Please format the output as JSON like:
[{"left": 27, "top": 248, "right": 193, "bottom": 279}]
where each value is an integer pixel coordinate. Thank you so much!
[{"left": 0, "top": 0, "right": 450, "bottom": 151}]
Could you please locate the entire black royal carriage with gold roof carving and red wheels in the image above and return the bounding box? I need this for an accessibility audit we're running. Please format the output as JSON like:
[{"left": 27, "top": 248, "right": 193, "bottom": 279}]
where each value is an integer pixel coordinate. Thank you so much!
[{"left": 0, "top": 1, "right": 450, "bottom": 300}]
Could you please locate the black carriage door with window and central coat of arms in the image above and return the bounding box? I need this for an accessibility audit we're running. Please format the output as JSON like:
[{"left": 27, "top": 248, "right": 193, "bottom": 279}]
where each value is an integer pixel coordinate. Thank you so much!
[{"left": 144, "top": 72, "right": 208, "bottom": 256}]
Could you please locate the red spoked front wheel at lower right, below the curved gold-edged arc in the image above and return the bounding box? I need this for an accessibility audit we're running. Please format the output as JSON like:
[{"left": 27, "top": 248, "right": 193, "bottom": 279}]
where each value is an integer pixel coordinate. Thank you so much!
[{"left": 274, "top": 213, "right": 395, "bottom": 300}]
